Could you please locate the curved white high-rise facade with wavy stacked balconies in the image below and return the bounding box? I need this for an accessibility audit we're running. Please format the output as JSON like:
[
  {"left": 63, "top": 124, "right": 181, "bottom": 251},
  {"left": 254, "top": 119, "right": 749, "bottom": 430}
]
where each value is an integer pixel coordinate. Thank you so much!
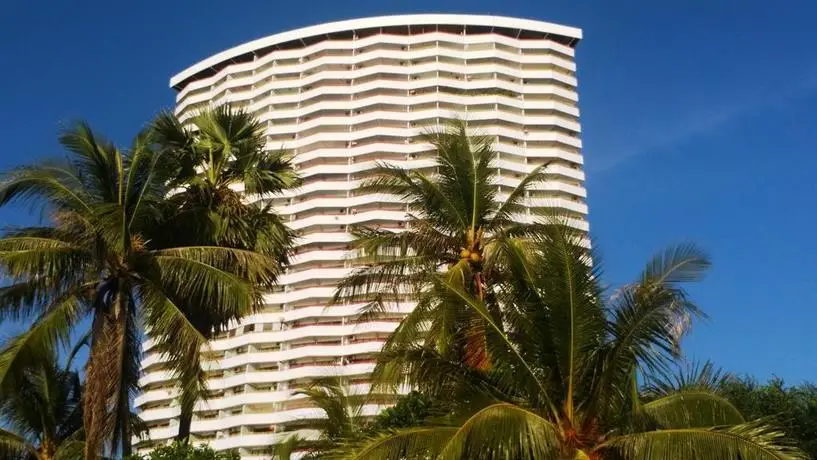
[{"left": 135, "top": 15, "right": 587, "bottom": 459}]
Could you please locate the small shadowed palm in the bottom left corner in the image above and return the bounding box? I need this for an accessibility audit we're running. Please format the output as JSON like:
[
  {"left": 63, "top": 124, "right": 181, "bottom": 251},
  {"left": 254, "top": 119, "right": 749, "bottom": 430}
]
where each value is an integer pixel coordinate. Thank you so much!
[{"left": 0, "top": 346, "right": 83, "bottom": 460}]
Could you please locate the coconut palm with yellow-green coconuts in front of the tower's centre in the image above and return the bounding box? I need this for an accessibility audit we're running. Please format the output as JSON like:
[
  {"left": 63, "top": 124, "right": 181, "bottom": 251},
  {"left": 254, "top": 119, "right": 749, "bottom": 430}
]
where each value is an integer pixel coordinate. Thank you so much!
[{"left": 335, "top": 121, "right": 547, "bottom": 369}]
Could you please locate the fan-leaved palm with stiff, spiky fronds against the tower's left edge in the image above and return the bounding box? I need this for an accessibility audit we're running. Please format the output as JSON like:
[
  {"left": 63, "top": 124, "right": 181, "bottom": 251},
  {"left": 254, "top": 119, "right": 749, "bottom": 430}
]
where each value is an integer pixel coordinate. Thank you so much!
[{"left": 152, "top": 106, "right": 300, "bottom": 441}]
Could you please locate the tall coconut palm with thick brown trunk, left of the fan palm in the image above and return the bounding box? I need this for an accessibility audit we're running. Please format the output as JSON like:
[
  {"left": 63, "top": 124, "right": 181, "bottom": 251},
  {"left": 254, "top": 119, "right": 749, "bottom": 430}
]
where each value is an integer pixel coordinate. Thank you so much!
[{"left": 0, "top": 123, "right": 276, "bottom": 460}]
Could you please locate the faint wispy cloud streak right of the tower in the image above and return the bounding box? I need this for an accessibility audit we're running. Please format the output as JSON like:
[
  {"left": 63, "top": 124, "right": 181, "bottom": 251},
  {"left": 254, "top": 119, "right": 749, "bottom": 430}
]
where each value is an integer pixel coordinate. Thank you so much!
[{"left": 588, "top": 70, "right": 817, "bottom": 173}]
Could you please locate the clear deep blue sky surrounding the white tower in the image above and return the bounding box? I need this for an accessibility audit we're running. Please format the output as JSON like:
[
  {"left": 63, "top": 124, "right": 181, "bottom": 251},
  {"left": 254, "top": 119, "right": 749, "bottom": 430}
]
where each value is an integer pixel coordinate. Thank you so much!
[{"left": 0, "top": 0, "right": 817, "bottom": 383}]
